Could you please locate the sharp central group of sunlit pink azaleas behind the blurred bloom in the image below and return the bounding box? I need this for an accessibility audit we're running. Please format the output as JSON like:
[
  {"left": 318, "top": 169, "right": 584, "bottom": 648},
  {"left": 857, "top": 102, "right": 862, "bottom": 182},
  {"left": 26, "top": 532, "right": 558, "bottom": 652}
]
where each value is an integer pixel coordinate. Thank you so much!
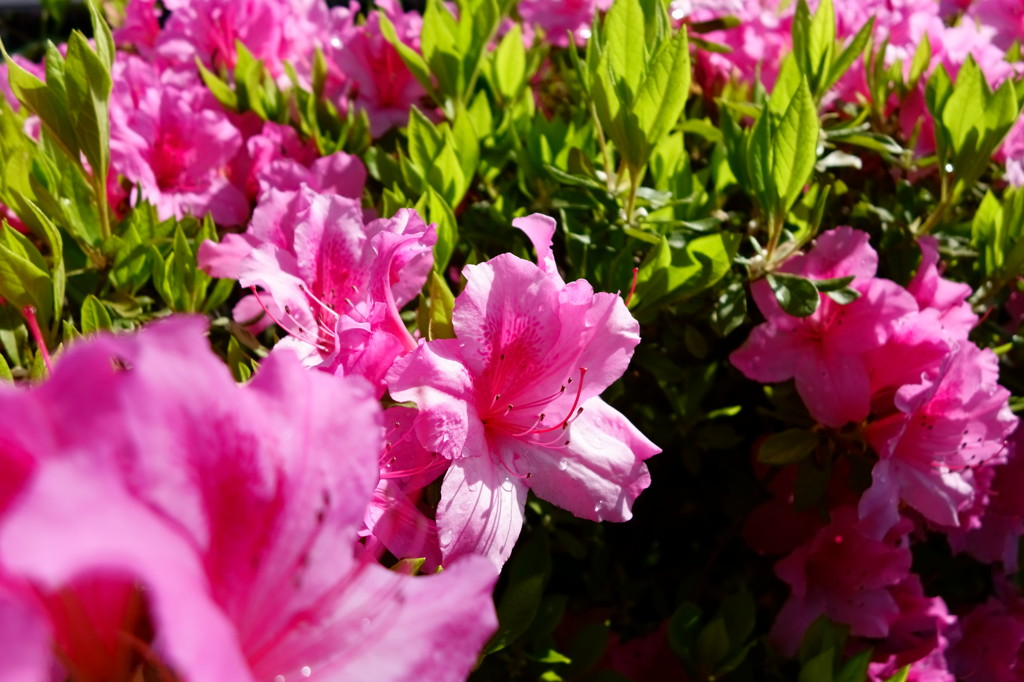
[{"left": 200, "top": 182, "right": 658, "bottom": 567}]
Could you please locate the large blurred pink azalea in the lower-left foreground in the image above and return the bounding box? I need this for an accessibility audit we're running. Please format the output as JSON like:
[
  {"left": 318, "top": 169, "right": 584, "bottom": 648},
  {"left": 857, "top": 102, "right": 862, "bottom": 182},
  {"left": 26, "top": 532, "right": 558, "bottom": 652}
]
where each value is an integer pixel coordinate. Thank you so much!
[{"left": 0, "top": 318, "right": 496, "bottom": 682}]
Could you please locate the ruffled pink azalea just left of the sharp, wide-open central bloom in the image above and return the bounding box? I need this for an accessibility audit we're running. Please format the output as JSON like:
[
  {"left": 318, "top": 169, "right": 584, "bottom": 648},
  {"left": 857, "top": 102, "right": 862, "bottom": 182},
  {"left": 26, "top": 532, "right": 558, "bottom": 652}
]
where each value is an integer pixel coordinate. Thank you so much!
[{"left": 199, "top": 185, "right": 436, "bottom": 392}]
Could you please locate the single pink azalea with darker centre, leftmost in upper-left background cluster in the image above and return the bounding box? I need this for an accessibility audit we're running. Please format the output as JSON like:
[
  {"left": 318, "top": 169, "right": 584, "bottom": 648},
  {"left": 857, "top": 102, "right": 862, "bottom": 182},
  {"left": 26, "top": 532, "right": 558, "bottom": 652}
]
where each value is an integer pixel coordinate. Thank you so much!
[{"left": 111, "top": 55, "right": 249, "bottom": 225}]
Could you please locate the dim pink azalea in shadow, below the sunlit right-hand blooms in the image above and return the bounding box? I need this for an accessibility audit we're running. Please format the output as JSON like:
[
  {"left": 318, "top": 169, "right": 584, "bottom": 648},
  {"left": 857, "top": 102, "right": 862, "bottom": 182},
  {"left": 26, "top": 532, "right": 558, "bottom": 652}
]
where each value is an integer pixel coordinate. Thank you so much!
[{"left": 771, "top": 507, "right": 910, "bottom": 656}]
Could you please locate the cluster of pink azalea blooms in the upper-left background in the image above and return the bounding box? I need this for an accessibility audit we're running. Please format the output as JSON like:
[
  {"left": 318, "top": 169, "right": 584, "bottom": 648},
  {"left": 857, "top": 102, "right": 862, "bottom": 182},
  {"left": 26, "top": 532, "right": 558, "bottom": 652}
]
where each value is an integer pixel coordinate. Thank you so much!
[{"left": 111, "top": 0, "right": 423, "bottom": 220}]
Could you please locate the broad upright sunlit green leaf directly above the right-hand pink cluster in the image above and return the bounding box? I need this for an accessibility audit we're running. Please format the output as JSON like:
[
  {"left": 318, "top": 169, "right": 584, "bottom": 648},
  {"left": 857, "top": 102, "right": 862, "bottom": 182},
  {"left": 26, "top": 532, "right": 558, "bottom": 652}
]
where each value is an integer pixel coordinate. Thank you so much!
[{"left": 771, "top": 82, "right": 819, "bottom": 216}]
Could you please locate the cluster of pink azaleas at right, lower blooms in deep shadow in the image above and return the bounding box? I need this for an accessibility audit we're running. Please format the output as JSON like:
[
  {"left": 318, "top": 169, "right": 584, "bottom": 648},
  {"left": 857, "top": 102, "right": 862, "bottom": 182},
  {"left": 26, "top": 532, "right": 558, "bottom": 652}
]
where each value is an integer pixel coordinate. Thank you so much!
[{"left": 731, "top": 227, "right": 1024, "bottom": 679}]
